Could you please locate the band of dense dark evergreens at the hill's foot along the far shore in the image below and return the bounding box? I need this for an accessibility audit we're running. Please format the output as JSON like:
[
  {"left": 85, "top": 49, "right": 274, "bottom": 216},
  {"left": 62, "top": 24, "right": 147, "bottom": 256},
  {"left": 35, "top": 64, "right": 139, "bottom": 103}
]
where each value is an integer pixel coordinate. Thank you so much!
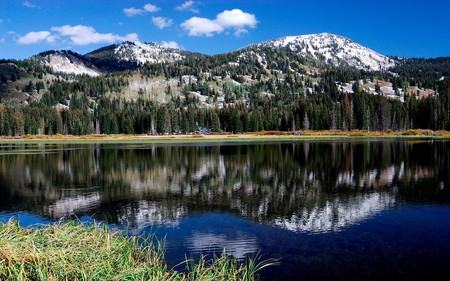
[{"left": 0, "top": 79, "right": 450, "bottom": 136}]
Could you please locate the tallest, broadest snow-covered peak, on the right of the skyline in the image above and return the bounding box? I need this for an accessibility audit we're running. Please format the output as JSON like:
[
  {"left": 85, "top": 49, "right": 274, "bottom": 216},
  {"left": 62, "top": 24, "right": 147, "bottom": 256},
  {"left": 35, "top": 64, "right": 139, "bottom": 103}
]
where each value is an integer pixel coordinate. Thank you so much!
[{"left": 253, "top": 33, "right": 396, "bottom": 71}]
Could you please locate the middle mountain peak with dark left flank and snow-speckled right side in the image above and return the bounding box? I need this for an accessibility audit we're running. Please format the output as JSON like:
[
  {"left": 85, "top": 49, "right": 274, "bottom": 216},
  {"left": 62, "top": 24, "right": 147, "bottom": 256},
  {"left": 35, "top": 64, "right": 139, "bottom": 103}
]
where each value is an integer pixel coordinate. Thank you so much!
[{"left": 86, "top": 41, "right": 199, "bottom": 71}]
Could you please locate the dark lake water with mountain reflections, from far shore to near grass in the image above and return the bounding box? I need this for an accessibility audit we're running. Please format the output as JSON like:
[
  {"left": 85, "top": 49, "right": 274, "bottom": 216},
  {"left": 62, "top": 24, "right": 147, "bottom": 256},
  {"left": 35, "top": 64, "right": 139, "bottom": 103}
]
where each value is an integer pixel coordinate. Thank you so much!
[{"left": 0, "top": 141, "right": 450, "bottom": 280}]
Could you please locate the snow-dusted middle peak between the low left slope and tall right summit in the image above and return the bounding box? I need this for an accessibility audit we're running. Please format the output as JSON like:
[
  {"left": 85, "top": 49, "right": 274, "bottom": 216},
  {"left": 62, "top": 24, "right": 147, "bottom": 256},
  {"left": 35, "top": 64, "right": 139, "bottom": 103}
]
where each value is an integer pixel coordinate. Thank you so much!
[{"left": 86, "top": 41, "right": 193, "bottom": 65}]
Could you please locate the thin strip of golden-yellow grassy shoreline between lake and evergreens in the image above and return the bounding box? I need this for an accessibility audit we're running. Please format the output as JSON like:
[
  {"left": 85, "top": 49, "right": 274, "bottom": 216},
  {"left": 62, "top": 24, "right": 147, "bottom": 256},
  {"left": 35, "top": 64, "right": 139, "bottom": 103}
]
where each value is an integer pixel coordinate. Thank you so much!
[{"left": 0, "top": 130, "right": 450, "bottom": 143}]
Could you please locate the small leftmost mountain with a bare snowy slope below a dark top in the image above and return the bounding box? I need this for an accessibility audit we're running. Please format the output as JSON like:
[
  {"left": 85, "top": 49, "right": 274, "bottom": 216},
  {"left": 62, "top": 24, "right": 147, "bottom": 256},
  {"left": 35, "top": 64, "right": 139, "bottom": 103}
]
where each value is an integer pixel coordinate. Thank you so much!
[{"left": 30, "top": 51, "right": 102, "bottom": 76}]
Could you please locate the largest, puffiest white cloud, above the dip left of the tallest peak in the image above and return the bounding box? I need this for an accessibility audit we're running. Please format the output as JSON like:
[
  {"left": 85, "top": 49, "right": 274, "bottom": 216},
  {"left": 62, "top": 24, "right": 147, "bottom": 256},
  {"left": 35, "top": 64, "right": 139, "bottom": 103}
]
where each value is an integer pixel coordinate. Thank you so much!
[{"left": 181, "top": 9, "right": 258, "bottom": 37}]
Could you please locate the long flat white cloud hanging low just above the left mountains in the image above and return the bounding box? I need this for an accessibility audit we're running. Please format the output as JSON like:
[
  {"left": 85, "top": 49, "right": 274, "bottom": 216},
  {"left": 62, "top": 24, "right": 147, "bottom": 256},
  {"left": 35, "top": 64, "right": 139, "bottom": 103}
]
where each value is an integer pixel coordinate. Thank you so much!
[{"left": 51, "top": 25, "right": 138, "bottom": 46}]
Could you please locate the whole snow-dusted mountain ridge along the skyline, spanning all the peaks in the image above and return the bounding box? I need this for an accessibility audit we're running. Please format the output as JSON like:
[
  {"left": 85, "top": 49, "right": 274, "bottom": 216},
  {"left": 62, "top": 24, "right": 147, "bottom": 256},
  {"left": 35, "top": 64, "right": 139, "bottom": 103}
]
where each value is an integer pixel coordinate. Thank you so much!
[{"left": 23, "top": 32, "right": 446, "bottom": 76}]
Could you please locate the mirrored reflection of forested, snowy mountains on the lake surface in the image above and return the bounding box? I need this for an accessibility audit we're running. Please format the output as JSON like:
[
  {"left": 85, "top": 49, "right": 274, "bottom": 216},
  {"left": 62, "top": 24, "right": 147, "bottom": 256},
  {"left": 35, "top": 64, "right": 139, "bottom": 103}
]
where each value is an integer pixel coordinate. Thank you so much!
[{"left": 0, "top": 141, "right": 450, "bottom": 234}]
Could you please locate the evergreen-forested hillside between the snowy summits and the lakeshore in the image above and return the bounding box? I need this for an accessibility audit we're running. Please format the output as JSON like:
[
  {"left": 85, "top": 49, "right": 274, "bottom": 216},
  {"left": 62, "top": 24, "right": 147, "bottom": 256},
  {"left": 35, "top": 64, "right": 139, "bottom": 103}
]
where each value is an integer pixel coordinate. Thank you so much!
[{"left": 0, "top": 34, "right": 450, "bottom": 136}]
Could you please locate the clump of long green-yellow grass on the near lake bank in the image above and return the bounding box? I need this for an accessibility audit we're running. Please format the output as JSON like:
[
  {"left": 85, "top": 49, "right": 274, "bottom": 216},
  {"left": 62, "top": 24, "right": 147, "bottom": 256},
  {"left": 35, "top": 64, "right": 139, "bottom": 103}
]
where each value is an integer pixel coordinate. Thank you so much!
[{"left": 0, "top": 221, "right": 276, "bottom": 281}]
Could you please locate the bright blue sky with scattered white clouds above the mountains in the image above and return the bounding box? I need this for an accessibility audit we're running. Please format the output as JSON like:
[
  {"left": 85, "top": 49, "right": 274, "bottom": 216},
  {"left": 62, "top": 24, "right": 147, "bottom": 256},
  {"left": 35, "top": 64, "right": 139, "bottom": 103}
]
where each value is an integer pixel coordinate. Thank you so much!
[{"left": 0, "top": 0, "right": 450, "bottom": 59}]
